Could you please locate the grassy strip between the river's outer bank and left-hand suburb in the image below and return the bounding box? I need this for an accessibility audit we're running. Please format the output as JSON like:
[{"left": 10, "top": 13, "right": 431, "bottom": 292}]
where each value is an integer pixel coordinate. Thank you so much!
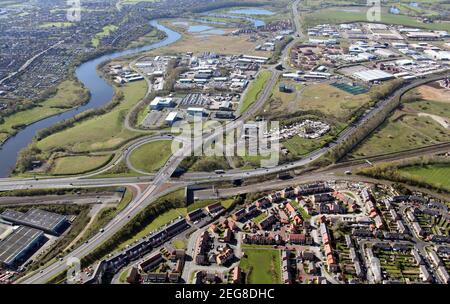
[{"left": 0, "top": 80, "right": 88, "bottom": 142}]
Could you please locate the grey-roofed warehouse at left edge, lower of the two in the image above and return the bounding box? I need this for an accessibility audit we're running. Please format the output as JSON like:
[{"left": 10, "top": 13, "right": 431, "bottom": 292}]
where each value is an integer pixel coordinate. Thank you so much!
[{"left": 0, "top": 226, "right": 46, "bottom": 268}]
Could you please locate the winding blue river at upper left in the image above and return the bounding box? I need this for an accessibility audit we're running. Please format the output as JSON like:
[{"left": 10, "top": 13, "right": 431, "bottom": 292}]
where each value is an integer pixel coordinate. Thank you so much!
[{"left": 0, "top": 20, "right": 181, "bottom": 177}]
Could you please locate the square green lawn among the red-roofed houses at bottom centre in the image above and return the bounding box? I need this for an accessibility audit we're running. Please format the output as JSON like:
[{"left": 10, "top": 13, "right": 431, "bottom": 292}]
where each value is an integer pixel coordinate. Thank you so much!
[{"left": 240, "top": 248, "right": 281, "bottom": 284}]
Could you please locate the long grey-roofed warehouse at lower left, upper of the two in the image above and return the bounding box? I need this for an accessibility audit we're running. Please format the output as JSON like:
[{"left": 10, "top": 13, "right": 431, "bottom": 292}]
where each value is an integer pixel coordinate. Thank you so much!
[{"left": 0, "top": 209, "right": 68, "bottom": 235}]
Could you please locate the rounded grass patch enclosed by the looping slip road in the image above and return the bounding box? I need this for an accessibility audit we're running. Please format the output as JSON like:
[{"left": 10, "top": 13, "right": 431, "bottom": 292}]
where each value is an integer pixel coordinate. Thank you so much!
[{"left": 130, "top": 140, "right": 172, "bottom": 172}]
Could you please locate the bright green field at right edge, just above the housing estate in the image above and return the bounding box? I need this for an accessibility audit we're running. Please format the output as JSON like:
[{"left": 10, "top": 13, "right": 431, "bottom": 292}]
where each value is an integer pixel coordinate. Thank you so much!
[{"left": 398, "top": 164, "right": 450, "bottom": 190}]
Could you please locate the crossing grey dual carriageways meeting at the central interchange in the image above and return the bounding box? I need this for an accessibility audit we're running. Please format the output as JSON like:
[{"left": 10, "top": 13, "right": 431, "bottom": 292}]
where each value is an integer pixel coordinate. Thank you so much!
[{"left": 7, "top": 0, "right": 448, "bottom": 284}]
